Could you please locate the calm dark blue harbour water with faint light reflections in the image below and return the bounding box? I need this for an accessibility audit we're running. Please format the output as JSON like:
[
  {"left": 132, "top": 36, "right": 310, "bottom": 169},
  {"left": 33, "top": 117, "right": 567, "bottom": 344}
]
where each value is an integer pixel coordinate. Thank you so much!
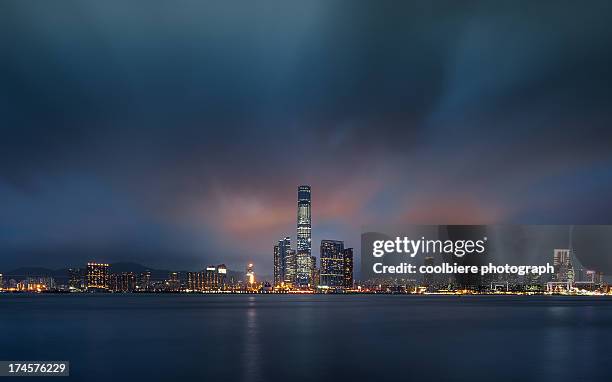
[{"left": 0, "top": 294, "right": 612, "bottom": 382}]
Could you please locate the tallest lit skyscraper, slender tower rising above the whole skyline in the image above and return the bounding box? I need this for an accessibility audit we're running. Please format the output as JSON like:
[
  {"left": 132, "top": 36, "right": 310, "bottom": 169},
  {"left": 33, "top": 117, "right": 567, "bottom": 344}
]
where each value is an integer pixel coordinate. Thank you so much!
[{"left": 295, "top": 185, "right": 312, "bottom": 287}]
